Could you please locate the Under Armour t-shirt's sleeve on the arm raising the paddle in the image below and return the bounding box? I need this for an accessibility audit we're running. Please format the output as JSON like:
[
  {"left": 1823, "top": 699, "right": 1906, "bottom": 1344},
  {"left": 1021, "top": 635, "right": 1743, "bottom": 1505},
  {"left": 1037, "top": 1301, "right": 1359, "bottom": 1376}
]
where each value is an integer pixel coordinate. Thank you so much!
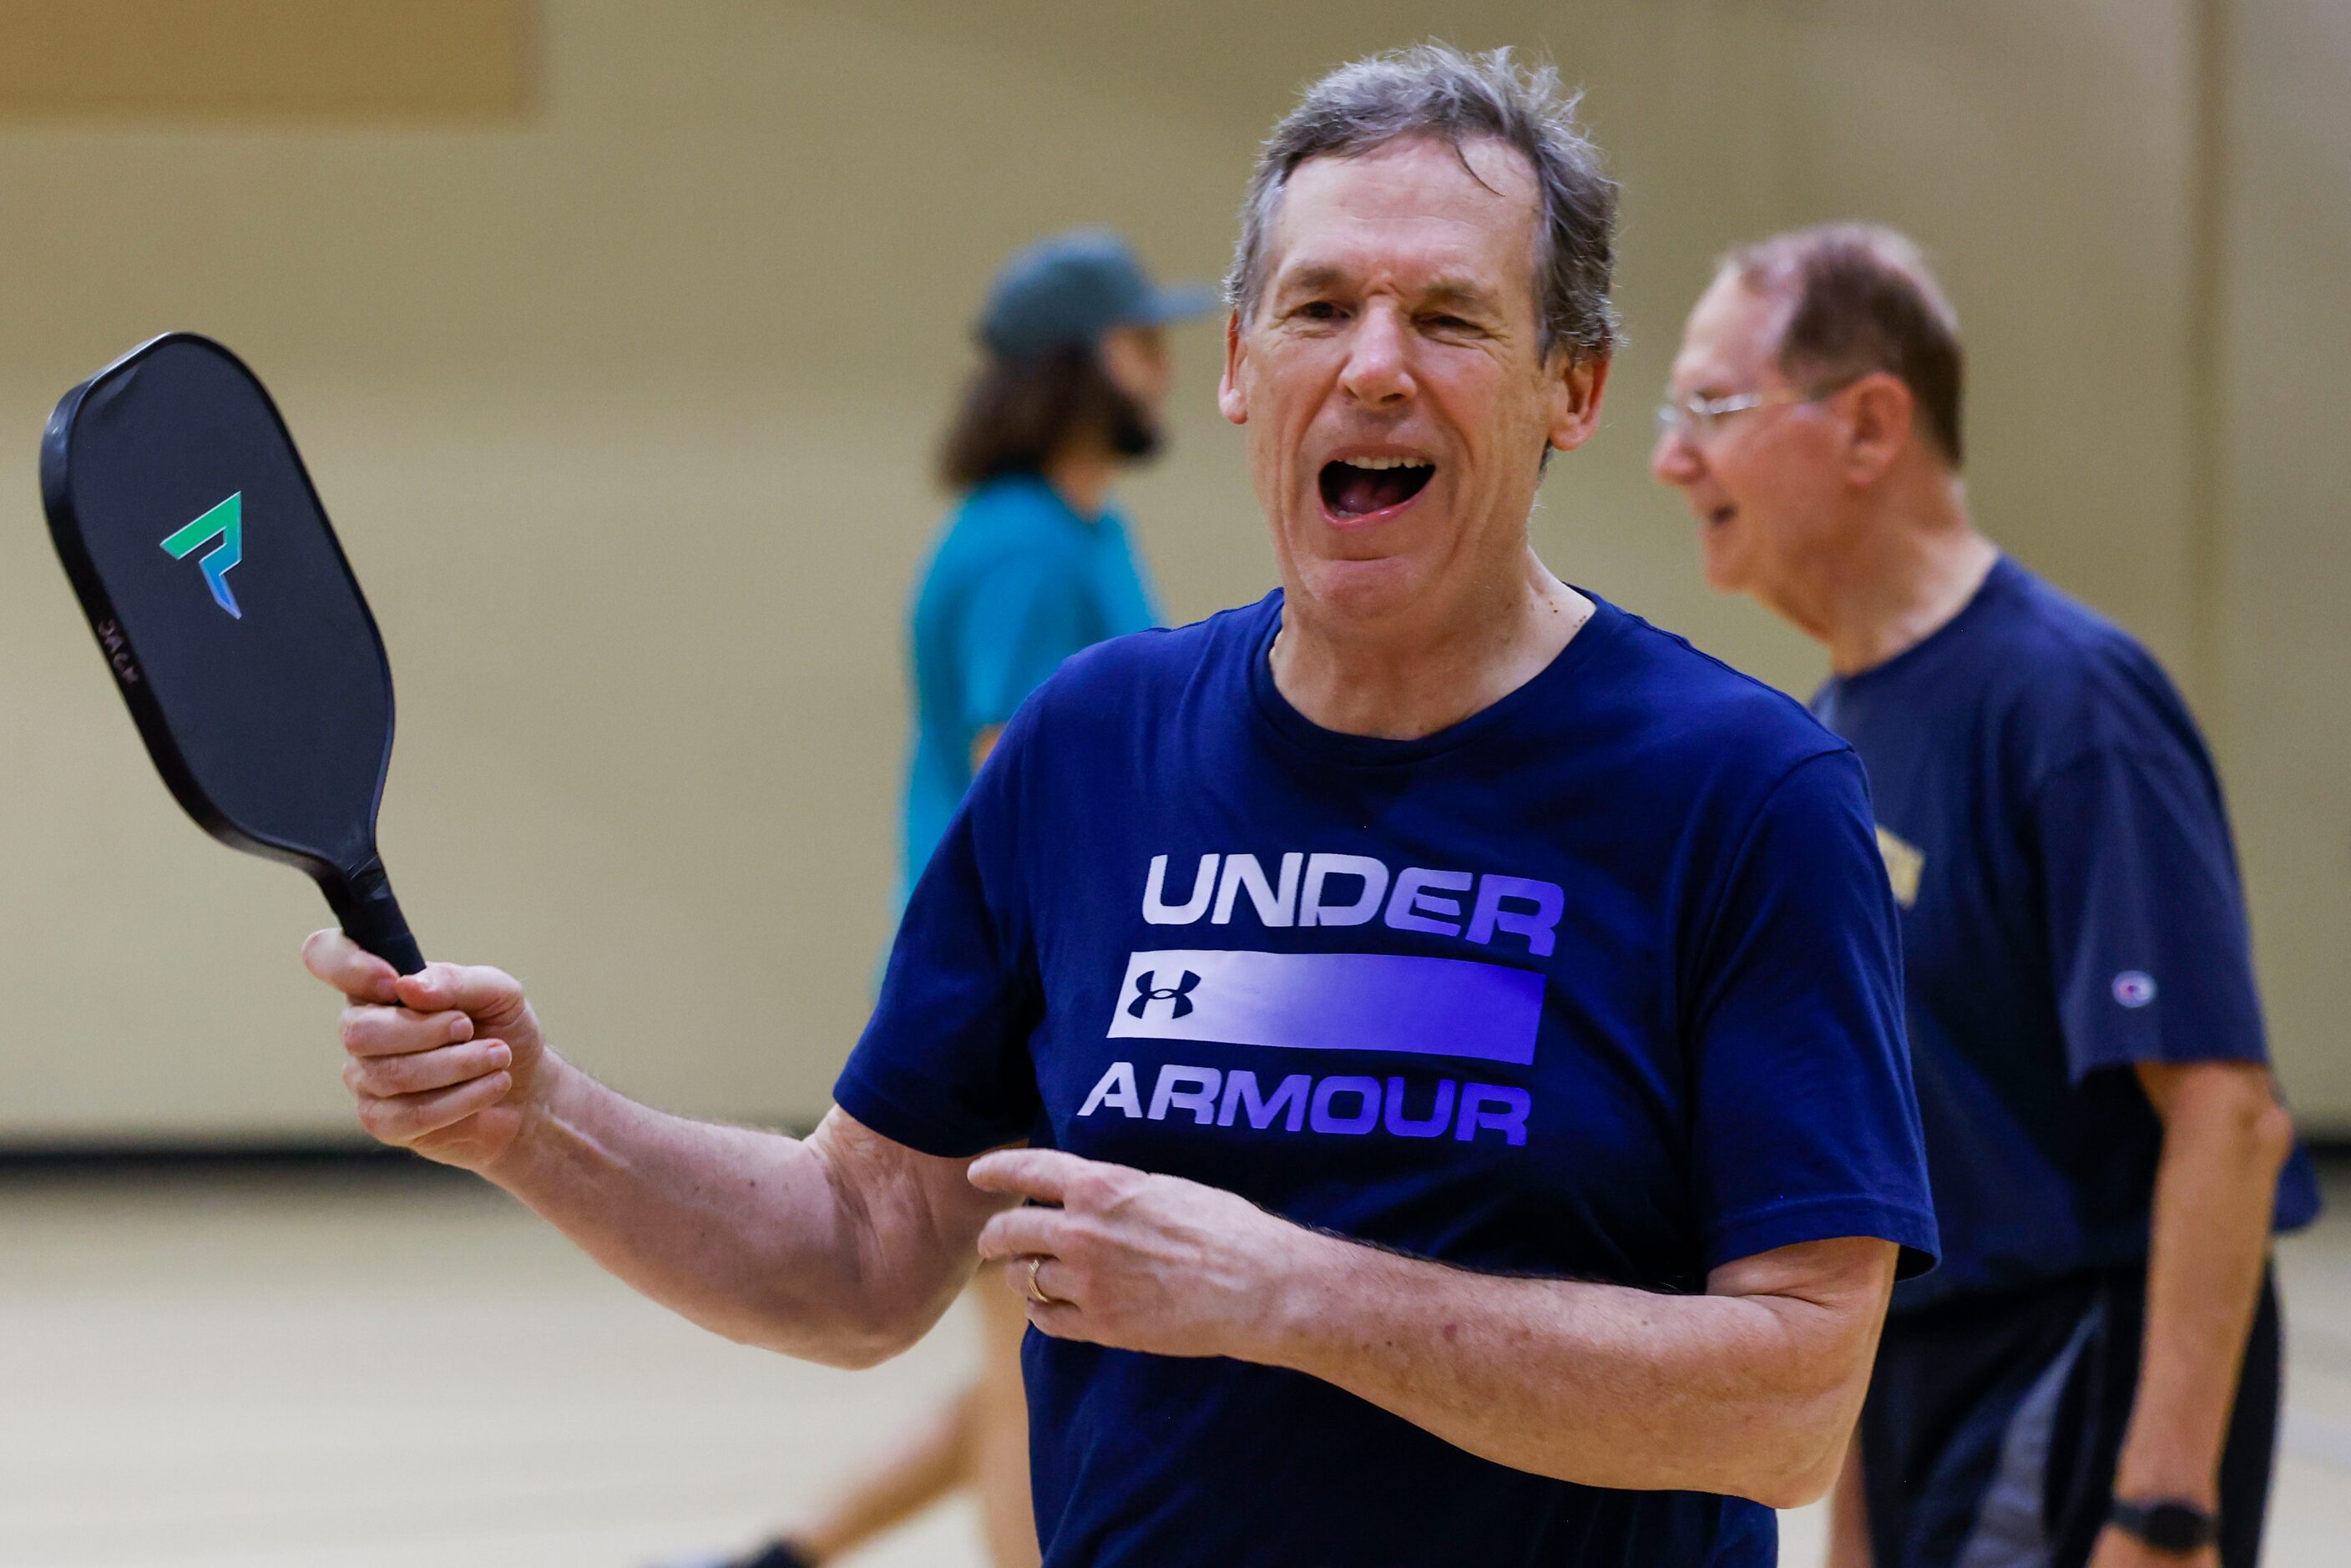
[{"left": 832, "top": 707, "right": 1044, "bottom": 1159}]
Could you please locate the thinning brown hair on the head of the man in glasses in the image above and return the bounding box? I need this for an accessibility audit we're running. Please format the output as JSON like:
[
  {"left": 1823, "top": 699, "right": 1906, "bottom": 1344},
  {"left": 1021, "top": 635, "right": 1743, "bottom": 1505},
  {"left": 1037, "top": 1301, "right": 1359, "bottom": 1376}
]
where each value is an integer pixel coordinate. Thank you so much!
[{"left": 1721, "top": 223, "right": 1965, "bottom": 468}]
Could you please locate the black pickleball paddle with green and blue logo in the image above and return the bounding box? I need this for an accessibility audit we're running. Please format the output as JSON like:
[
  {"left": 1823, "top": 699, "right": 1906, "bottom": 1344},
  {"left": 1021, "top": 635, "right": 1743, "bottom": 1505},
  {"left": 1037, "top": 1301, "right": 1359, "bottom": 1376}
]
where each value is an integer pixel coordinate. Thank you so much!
[{"left": 40, "top": 331, "right": 426, "bottom": 974}]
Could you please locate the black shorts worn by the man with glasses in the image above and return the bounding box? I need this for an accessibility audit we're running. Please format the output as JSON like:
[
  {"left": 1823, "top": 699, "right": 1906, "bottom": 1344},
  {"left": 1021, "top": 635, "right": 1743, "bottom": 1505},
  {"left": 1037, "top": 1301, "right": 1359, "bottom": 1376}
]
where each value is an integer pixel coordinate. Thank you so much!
[{"left": 1858, "top": 1269, "right": 2281, "bottom": 1568}]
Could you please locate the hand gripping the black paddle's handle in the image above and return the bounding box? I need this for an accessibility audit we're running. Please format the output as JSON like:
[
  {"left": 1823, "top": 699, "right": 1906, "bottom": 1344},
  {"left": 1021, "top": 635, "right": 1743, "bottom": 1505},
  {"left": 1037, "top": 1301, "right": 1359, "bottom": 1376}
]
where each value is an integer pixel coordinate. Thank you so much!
[{"left": 301, "top": 931, "right": 553, "bottom": 1171}]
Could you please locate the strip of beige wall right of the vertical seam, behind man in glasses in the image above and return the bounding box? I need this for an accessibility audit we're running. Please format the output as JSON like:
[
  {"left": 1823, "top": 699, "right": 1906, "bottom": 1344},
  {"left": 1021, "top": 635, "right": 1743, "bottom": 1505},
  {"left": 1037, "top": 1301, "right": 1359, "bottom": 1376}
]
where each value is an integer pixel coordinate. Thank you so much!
[{"left": 2198, "top": 0, "right": 2351, "bottom": 1147}]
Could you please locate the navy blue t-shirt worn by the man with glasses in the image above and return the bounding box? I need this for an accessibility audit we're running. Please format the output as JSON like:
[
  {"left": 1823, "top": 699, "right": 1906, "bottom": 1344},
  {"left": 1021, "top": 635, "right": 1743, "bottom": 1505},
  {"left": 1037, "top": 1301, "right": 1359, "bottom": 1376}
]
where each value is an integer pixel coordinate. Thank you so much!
[{"left": 1813, "top": 557, "right": 2318, "bottom": 1312}]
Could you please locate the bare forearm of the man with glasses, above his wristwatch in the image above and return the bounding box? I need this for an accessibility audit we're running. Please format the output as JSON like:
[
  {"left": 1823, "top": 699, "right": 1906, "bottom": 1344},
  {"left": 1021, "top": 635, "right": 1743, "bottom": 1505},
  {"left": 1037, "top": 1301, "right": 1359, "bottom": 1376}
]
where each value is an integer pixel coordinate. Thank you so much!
[{"left": 2116, "top": 1065, "right": 2293, "bottom": 1505}]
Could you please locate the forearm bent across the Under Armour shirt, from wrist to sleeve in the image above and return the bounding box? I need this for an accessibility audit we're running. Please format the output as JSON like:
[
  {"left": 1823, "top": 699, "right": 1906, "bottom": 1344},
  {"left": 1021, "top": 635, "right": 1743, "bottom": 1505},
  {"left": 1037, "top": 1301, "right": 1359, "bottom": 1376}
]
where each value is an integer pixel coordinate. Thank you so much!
[{"left": 1274, "top": 1237, "right": 1893, "bottom": 1507}]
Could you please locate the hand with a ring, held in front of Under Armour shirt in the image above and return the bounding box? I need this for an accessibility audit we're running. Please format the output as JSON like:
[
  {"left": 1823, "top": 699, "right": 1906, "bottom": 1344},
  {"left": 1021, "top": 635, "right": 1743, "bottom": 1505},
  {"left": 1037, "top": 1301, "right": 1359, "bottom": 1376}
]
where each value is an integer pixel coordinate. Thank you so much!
[{"left": 971, "top": 1150, "right": 1337, "bottom": 1361}]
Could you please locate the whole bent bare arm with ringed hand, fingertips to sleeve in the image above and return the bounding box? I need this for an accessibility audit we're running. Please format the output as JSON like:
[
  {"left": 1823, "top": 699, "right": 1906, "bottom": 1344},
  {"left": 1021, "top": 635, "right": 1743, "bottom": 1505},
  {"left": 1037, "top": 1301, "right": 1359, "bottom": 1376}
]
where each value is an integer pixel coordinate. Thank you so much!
[{"left": 968, "top": 1150, "right": 1898, "bottom": 1507}]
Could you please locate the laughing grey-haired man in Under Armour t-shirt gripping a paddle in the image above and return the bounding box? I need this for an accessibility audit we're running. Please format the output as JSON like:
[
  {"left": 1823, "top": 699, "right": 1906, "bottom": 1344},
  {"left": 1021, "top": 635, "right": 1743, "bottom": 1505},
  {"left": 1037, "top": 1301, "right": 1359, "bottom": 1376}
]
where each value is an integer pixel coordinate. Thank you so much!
[{"left": 308, "top": 44, "right": 1935, "bottom": 1568}]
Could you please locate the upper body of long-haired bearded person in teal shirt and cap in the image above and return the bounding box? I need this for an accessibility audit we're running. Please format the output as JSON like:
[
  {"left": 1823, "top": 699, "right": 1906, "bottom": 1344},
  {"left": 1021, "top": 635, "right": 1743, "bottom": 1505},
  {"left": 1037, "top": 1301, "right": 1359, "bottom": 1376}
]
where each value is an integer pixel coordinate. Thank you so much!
[{"left": 901, "top": 230, "right": 1211, "bottom": 898}]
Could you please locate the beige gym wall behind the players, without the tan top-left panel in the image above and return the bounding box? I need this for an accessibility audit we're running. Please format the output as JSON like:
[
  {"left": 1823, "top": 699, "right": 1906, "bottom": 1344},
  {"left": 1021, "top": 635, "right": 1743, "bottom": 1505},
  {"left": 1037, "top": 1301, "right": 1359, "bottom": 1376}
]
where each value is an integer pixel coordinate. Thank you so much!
[{"left": 0, "top": 0, "right": 2351, "bottom": 1142}]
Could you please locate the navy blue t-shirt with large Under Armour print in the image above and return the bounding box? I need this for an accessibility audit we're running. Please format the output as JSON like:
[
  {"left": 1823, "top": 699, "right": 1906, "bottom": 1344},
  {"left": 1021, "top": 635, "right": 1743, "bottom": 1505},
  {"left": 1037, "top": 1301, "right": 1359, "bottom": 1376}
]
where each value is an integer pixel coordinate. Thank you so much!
[{"left": 835, "top": 593, "right": 1935, "bottom": 1568}]
